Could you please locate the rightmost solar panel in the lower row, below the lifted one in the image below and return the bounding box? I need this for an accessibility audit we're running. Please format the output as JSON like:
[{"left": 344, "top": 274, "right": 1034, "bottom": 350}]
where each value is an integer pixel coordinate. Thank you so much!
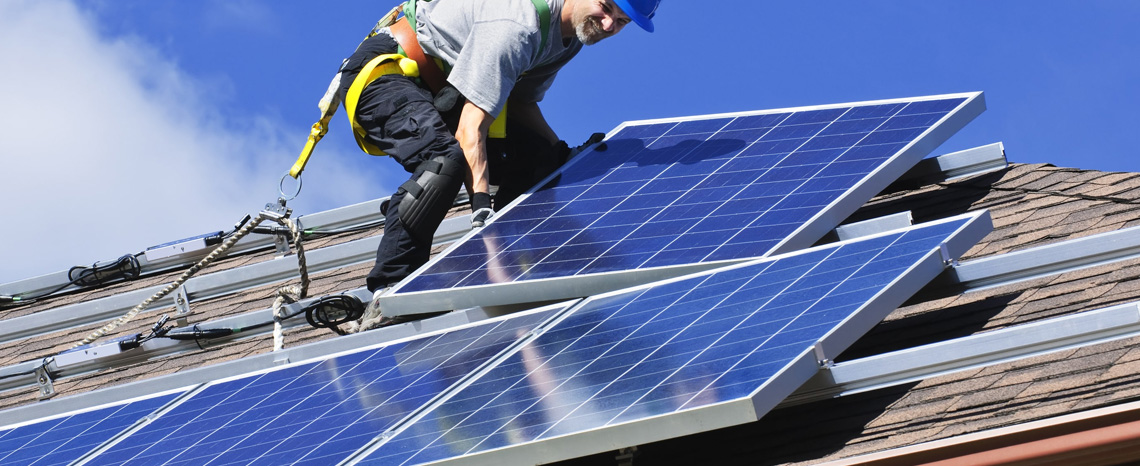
[{"left": 360, "top": 214, "right": 991, "bottom": 465}]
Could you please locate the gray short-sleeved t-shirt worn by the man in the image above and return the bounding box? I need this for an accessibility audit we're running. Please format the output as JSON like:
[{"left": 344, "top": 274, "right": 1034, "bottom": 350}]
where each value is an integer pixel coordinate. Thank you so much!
[{"left": 416, "top": 0, "right": 581, "bottom": 116}]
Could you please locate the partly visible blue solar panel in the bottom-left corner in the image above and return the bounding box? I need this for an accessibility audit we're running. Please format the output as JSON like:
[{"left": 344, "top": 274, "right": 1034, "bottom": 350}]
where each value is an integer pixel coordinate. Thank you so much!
[{"left": 0, "top": 393, "right": 178, "bottom": 466}]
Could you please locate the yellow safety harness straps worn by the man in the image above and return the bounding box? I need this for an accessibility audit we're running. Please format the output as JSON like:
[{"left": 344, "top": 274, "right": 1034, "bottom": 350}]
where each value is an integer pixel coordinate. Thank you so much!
[{"left": 288, "top": 0, "right": 551, "bottom": 178}]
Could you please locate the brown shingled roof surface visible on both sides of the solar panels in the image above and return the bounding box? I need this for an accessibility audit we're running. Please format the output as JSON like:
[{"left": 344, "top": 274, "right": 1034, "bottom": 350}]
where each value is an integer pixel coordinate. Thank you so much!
[{"left": 0, "top": 164, "right": 1140, "bottom": 464}]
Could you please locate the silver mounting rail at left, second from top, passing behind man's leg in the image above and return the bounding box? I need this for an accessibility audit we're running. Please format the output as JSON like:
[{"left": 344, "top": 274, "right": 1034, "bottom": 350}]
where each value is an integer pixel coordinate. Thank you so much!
[{"left": 0, "top": 215, "right": 471, "bottom": 343}]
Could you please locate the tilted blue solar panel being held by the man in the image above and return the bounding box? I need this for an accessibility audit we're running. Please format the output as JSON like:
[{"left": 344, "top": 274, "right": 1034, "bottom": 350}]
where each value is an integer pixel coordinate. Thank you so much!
[{"left": 381, "top": 93, "right": 985, "bottom": 314}]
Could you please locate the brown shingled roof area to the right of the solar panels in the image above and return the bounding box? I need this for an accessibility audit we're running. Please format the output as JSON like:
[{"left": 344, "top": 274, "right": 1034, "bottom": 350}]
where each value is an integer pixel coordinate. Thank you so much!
[{"left": 554, "top": 164, "right": 1140, "bottom": 465}]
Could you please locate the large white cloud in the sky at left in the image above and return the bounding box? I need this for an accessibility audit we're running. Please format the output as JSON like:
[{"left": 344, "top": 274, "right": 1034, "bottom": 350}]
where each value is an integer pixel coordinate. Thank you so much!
[{"left": 0, "top": 0, "right": 376, "bottom": 284}]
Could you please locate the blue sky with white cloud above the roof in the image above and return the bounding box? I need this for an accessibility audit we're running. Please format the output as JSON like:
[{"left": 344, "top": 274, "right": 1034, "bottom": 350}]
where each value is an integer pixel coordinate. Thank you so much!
[{"left": 0, "top": 0, "right": 1140, "bottom": 283}]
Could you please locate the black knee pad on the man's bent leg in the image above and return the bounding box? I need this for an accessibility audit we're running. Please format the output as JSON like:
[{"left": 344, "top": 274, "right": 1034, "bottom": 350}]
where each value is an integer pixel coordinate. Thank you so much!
[{"left": 398, "top": 156, "right": 466, "bottom": 243}]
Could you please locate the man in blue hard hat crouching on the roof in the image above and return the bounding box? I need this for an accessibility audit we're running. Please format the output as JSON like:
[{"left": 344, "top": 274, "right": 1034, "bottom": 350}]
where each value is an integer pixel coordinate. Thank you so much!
[{"left": 340, "top": 0, "right": 660, "bottom": 325}]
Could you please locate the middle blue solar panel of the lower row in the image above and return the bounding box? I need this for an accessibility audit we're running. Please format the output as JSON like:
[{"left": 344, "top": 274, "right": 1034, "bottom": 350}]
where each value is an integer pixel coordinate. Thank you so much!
[{"left": 83, "top": 310, "right": 556, "bottom": 465}]
